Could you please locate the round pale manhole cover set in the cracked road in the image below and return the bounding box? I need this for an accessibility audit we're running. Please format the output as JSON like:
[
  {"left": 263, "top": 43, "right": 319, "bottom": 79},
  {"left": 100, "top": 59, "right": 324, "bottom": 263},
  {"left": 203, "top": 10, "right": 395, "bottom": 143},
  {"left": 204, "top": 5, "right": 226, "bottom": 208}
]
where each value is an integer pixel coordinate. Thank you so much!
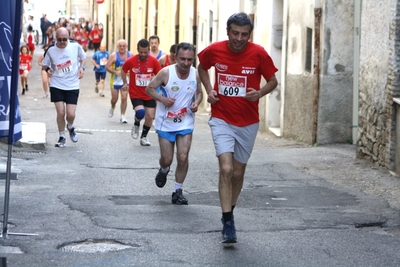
[{"left": 59, "top": 240, "right": 137, "bottom": 253}]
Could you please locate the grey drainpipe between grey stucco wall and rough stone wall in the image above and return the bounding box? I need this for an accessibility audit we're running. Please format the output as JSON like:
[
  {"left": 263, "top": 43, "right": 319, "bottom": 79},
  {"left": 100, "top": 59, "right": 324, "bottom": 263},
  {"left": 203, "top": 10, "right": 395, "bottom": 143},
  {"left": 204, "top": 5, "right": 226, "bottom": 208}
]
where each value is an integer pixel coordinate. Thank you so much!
[{"left": 352, "top": 0, "right": 361, "bottom": 145}]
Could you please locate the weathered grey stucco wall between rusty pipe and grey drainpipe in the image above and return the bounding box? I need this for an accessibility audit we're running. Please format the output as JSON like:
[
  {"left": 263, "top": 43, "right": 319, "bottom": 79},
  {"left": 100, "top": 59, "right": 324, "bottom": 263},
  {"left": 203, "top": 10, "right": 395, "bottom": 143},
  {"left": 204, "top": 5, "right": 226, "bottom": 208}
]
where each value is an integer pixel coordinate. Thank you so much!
[{"left": 317, "top": 0, "right": 354, "bottom": 144}]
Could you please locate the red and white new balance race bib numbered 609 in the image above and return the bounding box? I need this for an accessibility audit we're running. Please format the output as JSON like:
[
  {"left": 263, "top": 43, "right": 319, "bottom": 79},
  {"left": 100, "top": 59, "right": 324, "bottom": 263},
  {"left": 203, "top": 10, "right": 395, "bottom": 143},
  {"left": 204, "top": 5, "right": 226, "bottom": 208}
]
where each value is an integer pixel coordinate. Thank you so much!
[{"left": 218, "top": 73, "right": 247, "bottom": 97}]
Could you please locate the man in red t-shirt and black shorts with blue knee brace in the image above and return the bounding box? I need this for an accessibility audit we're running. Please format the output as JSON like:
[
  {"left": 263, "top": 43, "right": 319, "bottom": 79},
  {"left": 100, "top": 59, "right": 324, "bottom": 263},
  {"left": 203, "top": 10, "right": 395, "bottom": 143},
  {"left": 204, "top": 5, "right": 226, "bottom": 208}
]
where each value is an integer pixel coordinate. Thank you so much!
[{"left": 121, "top": 39, "right": 161, "bottom": 146}]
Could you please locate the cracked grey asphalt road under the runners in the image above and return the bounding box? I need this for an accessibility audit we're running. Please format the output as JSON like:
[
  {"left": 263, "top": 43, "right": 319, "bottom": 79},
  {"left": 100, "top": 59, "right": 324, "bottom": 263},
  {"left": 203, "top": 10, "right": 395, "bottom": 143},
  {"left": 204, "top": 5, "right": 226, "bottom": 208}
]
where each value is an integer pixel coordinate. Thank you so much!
[{"left": 0, "top": 47, "right": 400, "bottom": 267}]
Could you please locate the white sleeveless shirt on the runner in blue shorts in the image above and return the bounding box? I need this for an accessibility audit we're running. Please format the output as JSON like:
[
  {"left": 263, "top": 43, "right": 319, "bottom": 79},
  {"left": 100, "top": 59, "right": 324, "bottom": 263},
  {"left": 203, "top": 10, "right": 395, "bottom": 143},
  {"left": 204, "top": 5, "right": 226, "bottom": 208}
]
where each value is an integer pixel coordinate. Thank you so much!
[{"left": 155, "top": 64, "right": 197, "bottom": 132}]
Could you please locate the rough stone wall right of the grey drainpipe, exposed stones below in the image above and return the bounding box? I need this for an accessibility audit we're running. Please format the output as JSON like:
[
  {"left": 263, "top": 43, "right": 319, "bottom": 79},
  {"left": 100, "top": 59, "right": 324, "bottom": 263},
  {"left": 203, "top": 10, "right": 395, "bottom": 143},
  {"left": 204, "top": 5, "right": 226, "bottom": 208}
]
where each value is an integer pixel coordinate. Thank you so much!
[{"left": 357, "top": 0, "right": 400, "bottom": 170}]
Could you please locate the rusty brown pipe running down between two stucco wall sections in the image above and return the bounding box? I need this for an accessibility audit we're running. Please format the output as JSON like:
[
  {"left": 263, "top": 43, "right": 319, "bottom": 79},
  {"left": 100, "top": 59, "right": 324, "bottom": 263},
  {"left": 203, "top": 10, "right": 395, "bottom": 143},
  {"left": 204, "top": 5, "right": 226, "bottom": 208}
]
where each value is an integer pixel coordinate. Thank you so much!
[{"left": 311, "top": 8, "right": 322, "bottom": 144}]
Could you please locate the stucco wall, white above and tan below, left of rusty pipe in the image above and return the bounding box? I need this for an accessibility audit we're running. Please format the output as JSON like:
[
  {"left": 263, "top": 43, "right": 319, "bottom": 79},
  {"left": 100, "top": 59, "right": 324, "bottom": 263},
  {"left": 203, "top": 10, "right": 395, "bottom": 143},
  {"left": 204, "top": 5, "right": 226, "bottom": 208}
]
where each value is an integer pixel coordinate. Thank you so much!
[{"left": 282, "top": 0, "right": 314, "bottom": 143}]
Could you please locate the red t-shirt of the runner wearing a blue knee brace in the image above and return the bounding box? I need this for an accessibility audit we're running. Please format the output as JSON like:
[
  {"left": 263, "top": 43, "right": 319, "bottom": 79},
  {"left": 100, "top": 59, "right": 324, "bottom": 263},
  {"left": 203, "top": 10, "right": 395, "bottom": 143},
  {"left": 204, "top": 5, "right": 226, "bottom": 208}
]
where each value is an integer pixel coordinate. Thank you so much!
[{"left": 122, "top": 55, "right": 161, "bottom": 100}]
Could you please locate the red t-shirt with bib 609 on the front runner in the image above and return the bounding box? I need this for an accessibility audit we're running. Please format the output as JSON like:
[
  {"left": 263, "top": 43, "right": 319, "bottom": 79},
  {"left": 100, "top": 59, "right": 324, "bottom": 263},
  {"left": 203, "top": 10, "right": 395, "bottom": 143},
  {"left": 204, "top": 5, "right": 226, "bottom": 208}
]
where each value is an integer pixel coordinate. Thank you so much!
[{"left": 198, "top": 40, "right": 278, "bottom": 127}]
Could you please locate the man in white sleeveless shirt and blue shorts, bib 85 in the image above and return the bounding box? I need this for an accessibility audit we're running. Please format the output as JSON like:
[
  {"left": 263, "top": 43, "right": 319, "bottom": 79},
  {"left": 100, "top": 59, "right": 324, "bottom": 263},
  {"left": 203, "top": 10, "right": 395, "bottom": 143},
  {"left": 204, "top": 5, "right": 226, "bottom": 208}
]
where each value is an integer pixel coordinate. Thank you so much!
[{"left": 146, "top": 43, "right": 203, "bottom": 205}]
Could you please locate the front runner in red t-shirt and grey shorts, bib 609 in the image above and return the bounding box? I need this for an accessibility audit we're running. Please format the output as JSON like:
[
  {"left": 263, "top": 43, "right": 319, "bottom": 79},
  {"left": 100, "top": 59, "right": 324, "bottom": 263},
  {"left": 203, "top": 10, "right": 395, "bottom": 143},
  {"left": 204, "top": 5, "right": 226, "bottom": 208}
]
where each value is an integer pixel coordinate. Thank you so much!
[{"left": 198, "top": 12, "right": 278, "bottom": 246}]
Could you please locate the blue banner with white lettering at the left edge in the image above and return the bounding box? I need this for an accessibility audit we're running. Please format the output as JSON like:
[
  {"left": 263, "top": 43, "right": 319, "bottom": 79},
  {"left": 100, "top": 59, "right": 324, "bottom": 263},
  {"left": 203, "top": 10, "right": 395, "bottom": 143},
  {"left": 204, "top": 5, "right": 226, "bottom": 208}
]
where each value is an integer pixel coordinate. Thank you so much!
[{"left": 0, "top": 0, "right": 22, "bottom": 144}]
